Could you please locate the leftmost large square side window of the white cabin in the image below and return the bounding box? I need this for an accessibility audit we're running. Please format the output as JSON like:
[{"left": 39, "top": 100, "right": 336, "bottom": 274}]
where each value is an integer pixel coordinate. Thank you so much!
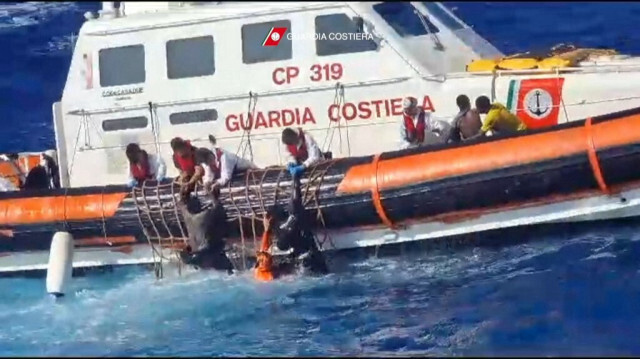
[{"left": 98, "top": 45, "right": 145, "bottom": 87}]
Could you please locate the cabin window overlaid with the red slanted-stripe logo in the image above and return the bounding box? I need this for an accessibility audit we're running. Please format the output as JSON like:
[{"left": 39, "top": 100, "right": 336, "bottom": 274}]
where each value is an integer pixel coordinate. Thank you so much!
[{"left": 242, "top": 20, "right": 292, "bottom": 64}]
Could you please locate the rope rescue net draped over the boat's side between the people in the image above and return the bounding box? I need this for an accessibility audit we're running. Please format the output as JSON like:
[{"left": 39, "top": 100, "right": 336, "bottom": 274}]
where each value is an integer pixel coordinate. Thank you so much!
[{"left": 131, "top": 162, "right": 335, "bottom": 278}]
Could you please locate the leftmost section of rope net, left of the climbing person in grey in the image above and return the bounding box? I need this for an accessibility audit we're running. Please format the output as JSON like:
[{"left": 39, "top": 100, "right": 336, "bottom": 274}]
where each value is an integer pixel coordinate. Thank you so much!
[{"left": 131, "top": 181, "right": 188, "bottom": 279}]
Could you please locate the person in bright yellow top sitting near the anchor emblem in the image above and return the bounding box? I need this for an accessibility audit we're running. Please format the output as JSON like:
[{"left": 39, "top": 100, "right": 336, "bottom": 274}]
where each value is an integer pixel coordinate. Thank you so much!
[{"left": 474, "top": 96, "right": 527, "bottom": 137}]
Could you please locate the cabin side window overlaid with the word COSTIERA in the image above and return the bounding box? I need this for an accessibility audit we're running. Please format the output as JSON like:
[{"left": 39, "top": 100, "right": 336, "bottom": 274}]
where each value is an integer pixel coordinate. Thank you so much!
[{"left": 315, "top": 14, "right": 378, "bottom": 56}]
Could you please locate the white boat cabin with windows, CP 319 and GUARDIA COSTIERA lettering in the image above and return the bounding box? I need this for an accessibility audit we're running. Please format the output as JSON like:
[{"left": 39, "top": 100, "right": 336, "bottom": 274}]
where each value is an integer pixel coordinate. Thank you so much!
[{"left": 54, "top": 2, "right": 501, "bottom": 187}]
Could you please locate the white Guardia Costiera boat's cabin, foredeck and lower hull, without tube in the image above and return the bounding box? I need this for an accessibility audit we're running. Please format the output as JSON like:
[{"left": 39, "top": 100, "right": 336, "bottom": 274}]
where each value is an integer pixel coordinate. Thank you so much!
[{"left": 0, "top": 1, "right": 640, "bottom": 271}]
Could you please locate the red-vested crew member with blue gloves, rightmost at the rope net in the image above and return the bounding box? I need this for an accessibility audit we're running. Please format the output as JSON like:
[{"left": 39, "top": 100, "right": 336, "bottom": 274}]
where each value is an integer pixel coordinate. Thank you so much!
[{"left": 282, "top": 127, "right": 323, "bottom": 176}]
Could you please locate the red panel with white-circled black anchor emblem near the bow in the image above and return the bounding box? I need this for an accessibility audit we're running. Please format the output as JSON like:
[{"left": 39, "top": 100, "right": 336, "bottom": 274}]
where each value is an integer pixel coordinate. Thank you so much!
[{"left": 507, "top": 77, "right": 564, "bottom": 128}]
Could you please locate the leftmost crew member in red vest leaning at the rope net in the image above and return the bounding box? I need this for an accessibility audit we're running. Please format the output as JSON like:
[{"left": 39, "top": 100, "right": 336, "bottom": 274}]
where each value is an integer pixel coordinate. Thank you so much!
[{"left": 125, "top": 143, "right": 167, "bottom": 187}]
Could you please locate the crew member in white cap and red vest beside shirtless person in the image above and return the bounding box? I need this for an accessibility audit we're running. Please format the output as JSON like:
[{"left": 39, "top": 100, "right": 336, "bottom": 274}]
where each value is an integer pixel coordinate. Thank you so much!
[{"left": 400, "top": 97, "right": 451, "bottom": 149}]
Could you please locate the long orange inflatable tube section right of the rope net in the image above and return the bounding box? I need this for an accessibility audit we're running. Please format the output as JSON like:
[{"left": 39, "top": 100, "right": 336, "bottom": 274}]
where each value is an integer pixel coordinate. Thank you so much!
[{"left": 338, "top": 114, "right": 640, "bottom": 194}]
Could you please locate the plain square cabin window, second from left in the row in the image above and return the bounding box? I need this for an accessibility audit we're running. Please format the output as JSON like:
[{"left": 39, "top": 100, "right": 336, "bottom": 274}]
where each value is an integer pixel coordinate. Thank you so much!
[{"left": 167, "top": 36, "right": 215, "bottom": 79}]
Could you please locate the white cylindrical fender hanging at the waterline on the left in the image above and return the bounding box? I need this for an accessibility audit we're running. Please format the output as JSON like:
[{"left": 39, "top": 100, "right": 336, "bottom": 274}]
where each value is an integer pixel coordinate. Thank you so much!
[{"left": 47, "top": 232, "right": 74, "bottom": 297}]
